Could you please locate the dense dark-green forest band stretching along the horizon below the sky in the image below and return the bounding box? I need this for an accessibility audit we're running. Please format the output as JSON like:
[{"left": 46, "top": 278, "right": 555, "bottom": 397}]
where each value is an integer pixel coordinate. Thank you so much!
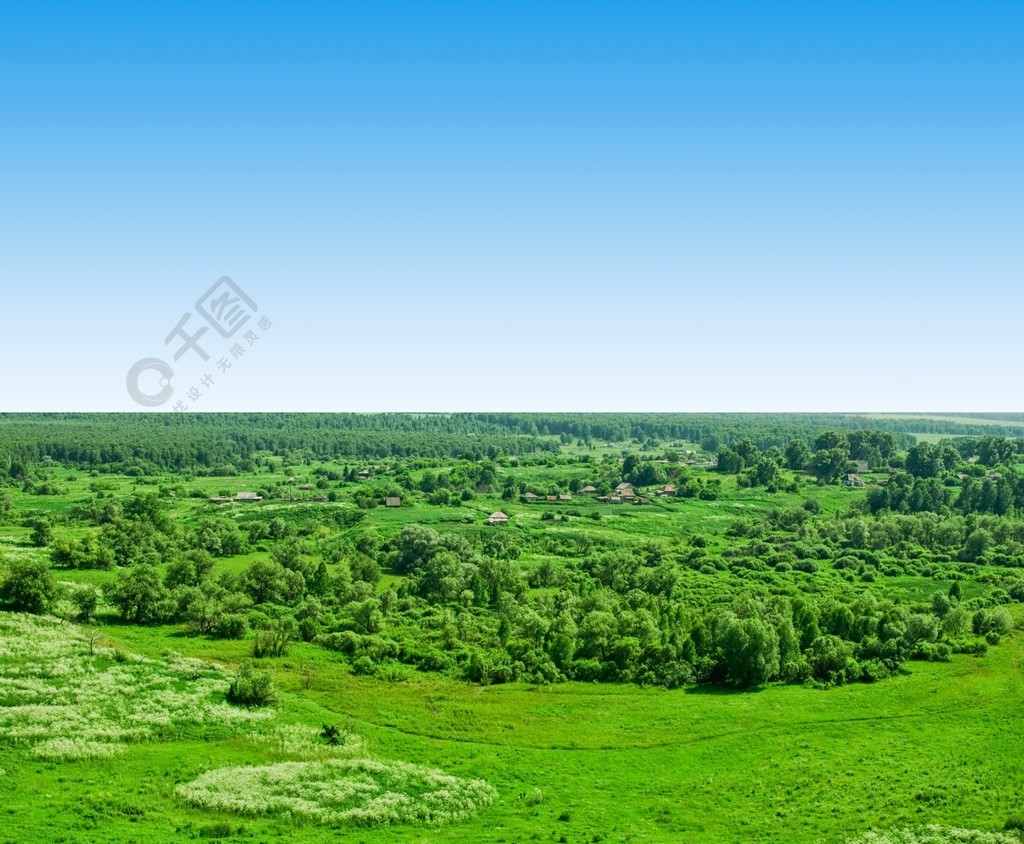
[{"left": 0, "top": 413, "right": 1021, "bottom": 477}]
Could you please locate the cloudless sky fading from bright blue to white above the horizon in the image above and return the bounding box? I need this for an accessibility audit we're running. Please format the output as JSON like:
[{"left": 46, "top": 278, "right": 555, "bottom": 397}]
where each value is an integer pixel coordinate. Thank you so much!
[{"left": 0, "top": 0, "right": 1024, "bottom": 411}]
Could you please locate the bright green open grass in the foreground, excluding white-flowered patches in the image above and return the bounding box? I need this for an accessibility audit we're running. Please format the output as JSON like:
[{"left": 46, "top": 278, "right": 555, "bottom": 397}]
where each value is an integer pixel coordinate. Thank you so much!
[{"left": 0, "top": 614, "right": 1024, "bottom": 842}]
